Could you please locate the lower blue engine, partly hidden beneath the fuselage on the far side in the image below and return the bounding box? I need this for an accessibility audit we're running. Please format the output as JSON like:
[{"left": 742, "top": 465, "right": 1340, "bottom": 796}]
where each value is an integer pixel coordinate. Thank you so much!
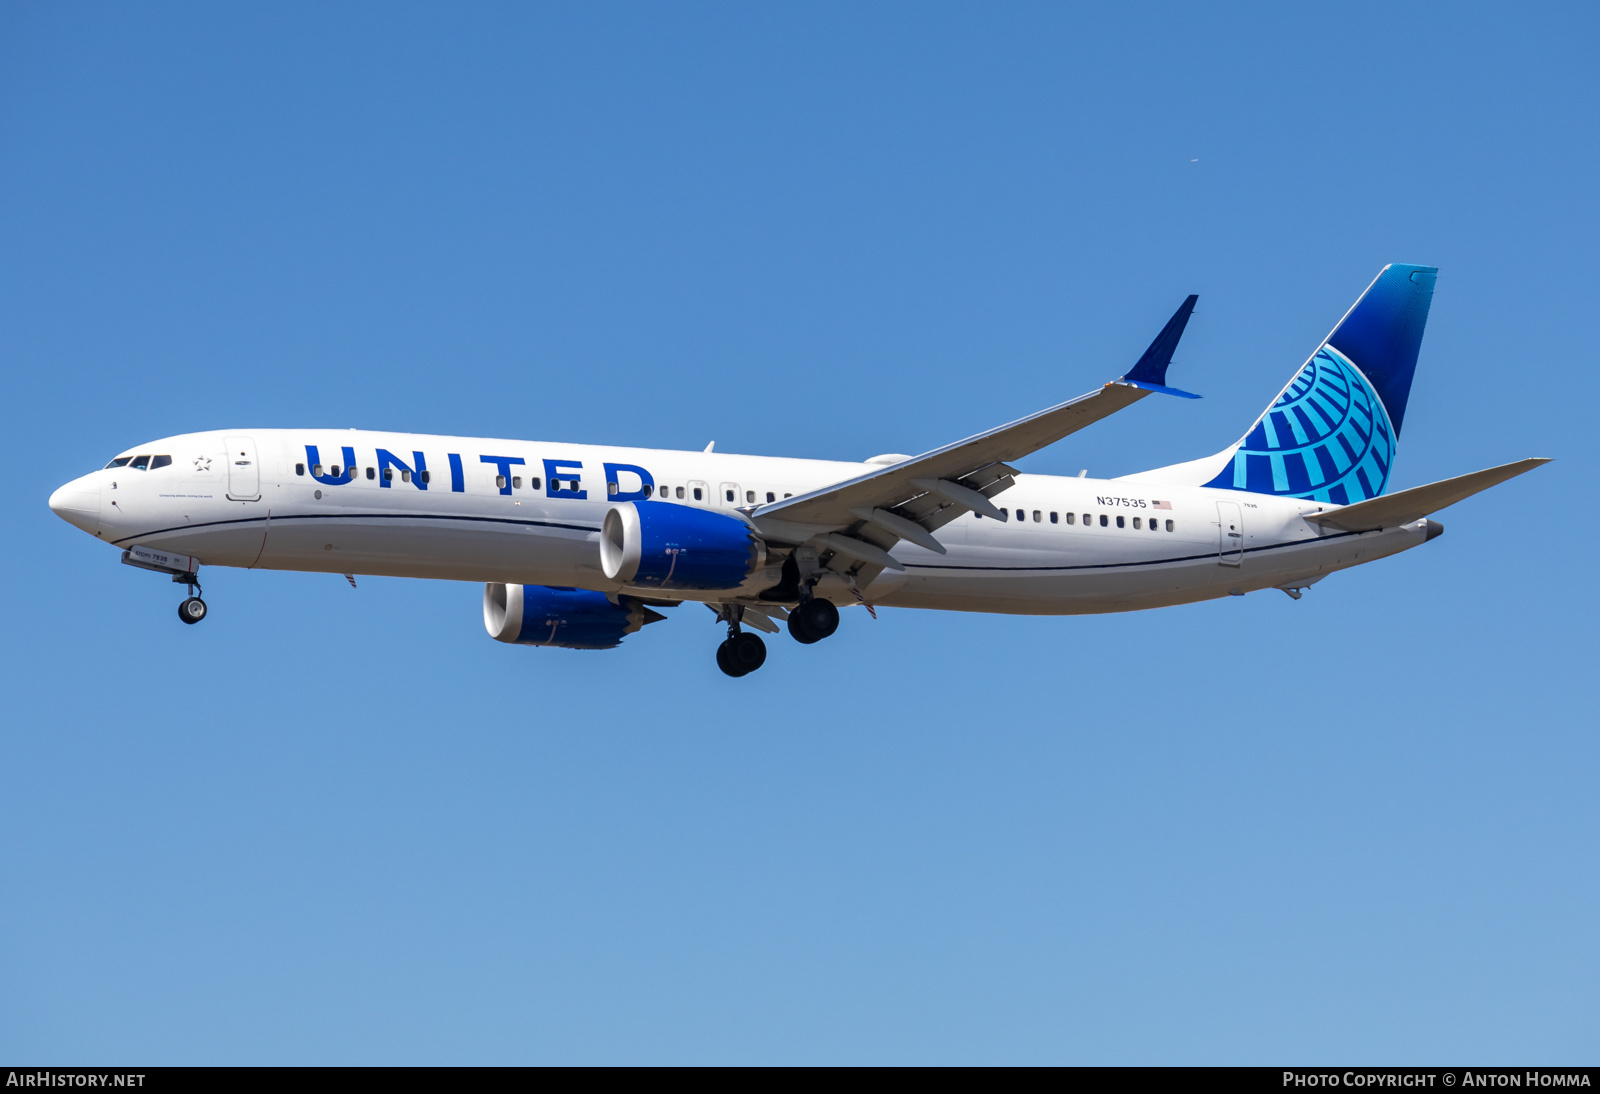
[{"left": 483, "top": 582, "right": 666, "bottom": 649}]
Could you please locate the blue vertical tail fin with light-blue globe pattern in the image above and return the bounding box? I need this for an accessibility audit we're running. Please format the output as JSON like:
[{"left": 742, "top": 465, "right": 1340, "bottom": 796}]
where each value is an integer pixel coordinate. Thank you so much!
[{"left": 1205, "top": 264, "right": 1438, "bottom": 505}]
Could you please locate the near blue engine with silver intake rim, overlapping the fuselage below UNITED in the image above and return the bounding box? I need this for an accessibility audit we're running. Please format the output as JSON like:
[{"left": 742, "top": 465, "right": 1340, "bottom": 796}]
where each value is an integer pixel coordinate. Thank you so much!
[{"left": 600, "top": 502, "right": 766, "bottom": 589}]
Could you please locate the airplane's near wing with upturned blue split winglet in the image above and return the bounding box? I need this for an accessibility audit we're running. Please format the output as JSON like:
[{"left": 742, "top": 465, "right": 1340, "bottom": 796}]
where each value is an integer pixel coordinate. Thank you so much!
[{"left": 750, "top": 296, "right": 1198, "bottom": 569}]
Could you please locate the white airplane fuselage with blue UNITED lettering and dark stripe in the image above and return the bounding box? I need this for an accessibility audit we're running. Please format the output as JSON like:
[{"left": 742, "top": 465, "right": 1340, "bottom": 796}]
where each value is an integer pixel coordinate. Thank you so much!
[{"left": 53, "top": 429, "right": 1427, "bottom": 614}]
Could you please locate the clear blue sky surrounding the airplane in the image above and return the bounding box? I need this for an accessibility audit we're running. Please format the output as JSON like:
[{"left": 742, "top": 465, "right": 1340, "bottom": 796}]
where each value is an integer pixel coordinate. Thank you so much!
[{"left": 0, "top": 3, "right": 1600, "bottom": 1064}]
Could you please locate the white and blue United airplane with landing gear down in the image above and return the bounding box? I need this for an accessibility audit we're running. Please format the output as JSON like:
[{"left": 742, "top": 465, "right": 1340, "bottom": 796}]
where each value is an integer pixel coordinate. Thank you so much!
[{"left": 50, "top": 264, "right": 1549, "bottom": 677}]
